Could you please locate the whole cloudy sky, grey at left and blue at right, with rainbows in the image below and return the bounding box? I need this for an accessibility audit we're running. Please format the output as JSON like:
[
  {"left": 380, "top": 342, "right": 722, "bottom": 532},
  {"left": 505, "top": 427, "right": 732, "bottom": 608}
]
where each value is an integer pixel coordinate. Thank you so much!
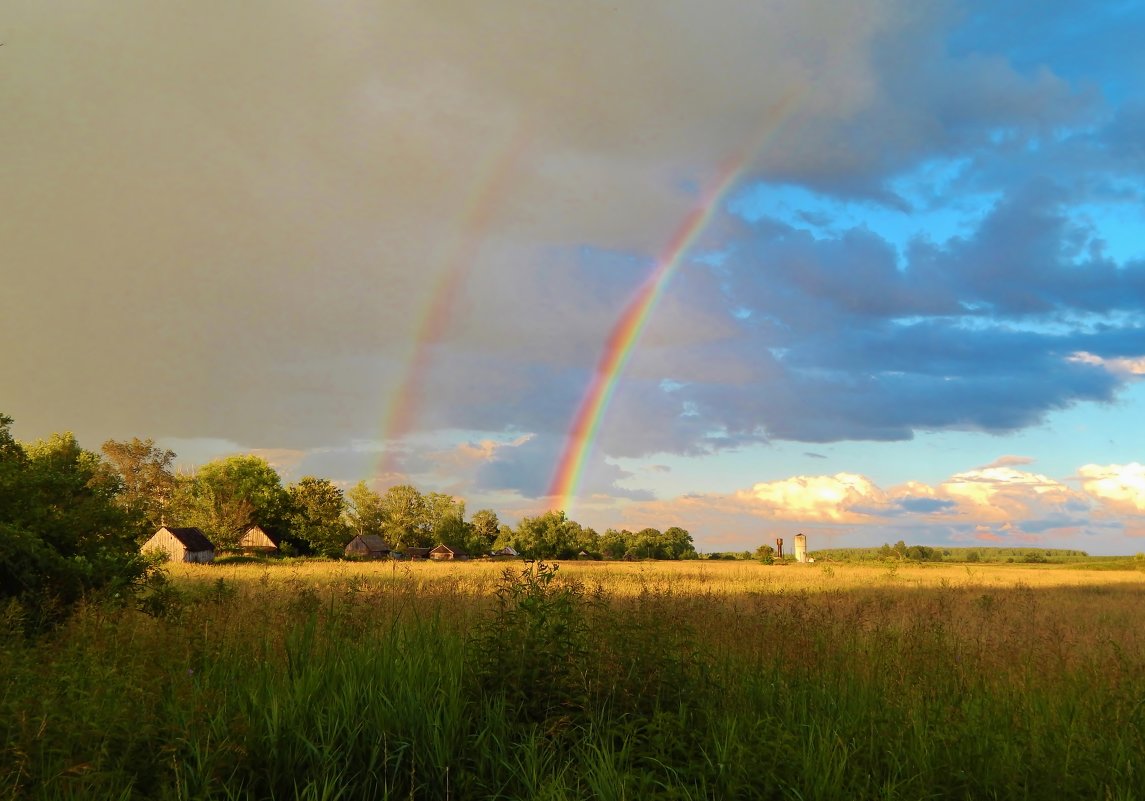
[{"left": 0, "top": 0, "right": 1145, "bottom": 554}]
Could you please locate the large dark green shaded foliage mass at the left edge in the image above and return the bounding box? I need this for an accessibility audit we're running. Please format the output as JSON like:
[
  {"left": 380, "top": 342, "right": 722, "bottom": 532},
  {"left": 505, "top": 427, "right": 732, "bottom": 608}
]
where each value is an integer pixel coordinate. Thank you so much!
[{"left": 0, "top": 414, "right": 148, "bottom": 628}]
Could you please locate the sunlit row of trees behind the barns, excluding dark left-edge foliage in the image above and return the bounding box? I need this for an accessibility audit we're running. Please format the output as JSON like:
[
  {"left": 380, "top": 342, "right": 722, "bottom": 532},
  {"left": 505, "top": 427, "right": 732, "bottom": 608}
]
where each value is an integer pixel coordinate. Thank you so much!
[{"left": 103, "top": 439, "right": 696, "bottom": 560}]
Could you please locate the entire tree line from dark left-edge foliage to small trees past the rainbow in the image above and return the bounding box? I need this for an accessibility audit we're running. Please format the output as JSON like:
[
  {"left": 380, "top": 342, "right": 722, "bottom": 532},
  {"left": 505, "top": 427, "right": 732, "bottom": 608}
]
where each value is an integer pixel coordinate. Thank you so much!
[{"left": 0, "top": 414, "right": 696, "bottom": 611}]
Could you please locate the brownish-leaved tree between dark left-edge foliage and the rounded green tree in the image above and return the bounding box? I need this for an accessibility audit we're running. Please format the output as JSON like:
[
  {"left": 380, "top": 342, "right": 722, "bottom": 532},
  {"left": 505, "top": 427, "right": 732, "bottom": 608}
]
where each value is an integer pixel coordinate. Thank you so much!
[{"left": 101, "top": 437, "right": 176, "bottom": 545}]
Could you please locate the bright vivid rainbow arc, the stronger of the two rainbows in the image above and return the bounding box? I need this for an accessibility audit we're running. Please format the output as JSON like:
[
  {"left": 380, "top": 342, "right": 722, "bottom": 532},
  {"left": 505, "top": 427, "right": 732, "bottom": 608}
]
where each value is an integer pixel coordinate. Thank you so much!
[{"left": 547, "top": 93, "right": 796, "bottom": 511}]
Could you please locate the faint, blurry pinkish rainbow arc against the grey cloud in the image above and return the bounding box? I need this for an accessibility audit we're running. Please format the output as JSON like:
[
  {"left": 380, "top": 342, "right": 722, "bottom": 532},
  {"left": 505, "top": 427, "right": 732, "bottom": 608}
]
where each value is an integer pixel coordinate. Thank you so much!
[{"left": 377, "top": 126, "right": 528, "bottom": 476}]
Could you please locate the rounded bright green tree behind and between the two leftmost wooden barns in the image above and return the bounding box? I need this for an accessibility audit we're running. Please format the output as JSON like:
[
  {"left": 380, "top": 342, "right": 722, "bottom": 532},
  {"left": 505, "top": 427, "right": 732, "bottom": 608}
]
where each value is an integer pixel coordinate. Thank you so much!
[{"left": 168, "top": 454, "right": 290, "bottom": 549}]
